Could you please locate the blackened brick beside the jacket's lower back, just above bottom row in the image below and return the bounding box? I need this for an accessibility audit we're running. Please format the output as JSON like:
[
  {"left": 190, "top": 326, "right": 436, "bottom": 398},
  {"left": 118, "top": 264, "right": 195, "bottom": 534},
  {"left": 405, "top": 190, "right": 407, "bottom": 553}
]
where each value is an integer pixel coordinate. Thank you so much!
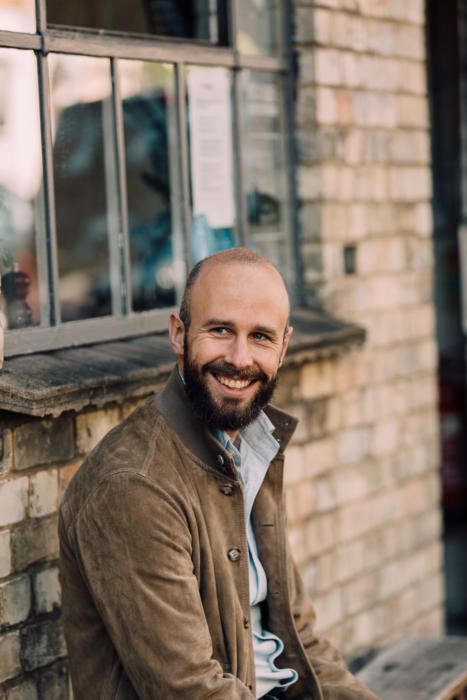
[{"left": 21, "top": 621, "right": 66, "bottom": 671}]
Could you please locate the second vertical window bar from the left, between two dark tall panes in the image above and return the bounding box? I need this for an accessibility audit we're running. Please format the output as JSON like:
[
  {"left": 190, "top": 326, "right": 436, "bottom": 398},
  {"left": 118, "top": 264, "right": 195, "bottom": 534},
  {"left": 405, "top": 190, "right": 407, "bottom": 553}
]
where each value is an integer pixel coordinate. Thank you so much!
[{"left": 109, "top": 58, "right": 133, "bottom": 315}]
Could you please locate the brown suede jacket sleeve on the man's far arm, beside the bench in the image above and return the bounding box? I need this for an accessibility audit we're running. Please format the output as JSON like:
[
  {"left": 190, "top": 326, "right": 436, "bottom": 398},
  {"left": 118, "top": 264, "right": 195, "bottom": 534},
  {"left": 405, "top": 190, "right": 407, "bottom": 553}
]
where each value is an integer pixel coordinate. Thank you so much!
[{"left": 288, "top": 540, "right": 378, "bottom": 700}]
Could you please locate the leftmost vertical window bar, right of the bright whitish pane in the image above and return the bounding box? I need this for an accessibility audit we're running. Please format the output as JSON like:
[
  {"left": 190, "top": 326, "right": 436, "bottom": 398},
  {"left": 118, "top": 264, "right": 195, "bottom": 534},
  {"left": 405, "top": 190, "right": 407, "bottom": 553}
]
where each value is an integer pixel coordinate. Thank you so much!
[{"left": 37, "top": 53, "right": 61, "bottom": 326}]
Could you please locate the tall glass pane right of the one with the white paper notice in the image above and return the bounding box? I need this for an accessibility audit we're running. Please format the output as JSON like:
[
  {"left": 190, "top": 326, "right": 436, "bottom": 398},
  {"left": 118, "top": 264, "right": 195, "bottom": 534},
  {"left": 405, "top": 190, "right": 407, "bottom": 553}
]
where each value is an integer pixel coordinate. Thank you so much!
[{"left": 242, "top": 71, "right": 289, "bottom": 279}]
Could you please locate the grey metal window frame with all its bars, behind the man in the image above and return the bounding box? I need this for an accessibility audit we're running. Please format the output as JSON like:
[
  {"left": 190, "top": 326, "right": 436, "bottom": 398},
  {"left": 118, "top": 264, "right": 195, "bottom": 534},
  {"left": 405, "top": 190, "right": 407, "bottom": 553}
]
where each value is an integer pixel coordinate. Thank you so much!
[{"left": 0, "top": 0, "right": 300, "bottom": 357}]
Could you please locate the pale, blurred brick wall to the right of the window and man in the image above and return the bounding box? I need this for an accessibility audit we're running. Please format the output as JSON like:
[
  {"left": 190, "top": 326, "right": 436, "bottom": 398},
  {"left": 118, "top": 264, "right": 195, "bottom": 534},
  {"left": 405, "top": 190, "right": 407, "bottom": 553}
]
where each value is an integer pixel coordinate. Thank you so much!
[{"left": 292, "top": 0, "right": 443, "bottom": 657}]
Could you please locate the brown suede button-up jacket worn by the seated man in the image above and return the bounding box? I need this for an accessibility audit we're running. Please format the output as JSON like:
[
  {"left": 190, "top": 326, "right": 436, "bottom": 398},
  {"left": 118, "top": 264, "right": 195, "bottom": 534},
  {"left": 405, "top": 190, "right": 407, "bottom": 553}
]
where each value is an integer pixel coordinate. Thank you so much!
[{"left": 59, "top": 371, "right": 377, "bottom": 700}]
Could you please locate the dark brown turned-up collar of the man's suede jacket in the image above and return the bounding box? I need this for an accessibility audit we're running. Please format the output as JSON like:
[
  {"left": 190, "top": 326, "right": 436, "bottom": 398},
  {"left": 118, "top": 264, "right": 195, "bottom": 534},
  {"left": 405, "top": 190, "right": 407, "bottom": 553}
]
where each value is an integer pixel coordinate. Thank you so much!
[{"left": 155, "top": 366, "right": 298, "bottom": 477}]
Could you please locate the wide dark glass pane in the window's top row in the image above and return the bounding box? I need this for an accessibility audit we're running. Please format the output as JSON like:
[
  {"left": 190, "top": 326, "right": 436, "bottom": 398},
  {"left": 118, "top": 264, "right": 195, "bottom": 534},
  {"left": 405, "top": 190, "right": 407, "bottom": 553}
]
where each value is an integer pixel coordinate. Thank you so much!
[{"left": 47, "top": 0, "right": 218, "bottom": 42}]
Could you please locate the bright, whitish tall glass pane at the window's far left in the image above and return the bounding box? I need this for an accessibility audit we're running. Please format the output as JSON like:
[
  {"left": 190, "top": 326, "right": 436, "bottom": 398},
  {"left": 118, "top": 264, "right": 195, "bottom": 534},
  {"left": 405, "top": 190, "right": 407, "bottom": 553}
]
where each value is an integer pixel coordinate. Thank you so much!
[{"left": 0, "top": 49, "right": 42, "bottom": 328}]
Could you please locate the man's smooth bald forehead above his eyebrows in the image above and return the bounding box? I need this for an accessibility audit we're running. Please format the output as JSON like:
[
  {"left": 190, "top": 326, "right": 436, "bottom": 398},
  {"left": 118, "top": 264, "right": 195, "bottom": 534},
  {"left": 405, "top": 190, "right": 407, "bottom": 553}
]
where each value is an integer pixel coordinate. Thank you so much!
[{"left": 190, "top": 263, "right": 289, "bottom": 327}]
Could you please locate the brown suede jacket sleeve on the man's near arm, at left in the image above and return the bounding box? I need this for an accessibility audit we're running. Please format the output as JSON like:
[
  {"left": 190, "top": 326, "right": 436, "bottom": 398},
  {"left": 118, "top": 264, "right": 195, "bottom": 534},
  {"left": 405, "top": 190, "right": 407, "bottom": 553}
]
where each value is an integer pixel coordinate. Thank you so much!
[{"left": 68, "top": 472, "right": 254, "bottom": 700}]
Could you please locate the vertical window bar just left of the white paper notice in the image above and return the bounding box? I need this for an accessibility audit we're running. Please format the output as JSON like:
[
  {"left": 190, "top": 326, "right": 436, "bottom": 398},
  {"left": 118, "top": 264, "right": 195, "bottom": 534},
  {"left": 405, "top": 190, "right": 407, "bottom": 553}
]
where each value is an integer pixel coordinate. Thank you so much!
[{"left": 175, "top": 63, "right": 193, "bottom": 270}]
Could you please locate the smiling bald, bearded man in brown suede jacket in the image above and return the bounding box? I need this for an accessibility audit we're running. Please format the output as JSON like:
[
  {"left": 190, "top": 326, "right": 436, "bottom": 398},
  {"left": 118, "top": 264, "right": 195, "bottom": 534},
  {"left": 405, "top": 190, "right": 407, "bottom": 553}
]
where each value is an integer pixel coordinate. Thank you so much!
[{"left": 60, "top": 248, "right": 375, "bottom": 700}]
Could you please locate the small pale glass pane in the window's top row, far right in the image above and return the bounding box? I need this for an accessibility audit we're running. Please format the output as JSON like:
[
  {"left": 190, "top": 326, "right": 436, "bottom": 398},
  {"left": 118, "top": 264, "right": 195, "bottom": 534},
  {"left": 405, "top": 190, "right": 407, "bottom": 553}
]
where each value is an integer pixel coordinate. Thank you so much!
[{"left": 237, "top": 0, "right": 280, "bottom": 56}]
